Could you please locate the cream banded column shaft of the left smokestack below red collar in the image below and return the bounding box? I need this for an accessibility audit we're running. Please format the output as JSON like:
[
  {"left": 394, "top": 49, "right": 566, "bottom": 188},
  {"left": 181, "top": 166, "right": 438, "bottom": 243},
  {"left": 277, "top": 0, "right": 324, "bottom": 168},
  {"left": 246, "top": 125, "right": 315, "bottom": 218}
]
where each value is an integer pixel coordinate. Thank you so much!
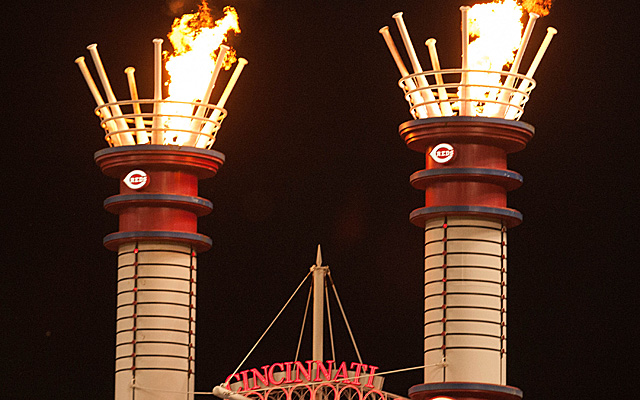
[{"left": 115, "top": 242, "right": 196, "bottom": 400}]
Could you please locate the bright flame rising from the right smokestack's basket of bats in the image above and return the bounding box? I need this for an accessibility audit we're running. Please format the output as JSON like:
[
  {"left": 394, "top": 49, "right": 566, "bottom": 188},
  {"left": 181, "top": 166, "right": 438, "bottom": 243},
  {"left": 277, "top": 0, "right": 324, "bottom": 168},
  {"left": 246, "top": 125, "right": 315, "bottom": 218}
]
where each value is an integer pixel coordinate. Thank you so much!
[{"left": 468, "top": 0, "right": 523, "bottom": 115}]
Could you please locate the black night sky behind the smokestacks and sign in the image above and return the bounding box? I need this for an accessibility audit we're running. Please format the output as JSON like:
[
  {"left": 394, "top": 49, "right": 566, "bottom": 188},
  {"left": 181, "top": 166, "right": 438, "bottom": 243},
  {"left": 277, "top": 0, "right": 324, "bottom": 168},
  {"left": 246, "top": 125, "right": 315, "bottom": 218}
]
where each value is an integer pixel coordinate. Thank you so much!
[{"left": 0, "top": 0, "right": 638, "bottom": 400}]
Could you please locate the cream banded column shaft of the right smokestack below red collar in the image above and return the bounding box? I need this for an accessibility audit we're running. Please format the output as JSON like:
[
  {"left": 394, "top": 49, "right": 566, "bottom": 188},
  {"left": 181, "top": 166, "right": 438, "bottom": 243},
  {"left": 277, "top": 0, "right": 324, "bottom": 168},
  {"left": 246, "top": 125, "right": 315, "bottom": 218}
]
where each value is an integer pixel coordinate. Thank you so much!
[{"left": 424, "top": 217, "right": 507, "bottom": 385}]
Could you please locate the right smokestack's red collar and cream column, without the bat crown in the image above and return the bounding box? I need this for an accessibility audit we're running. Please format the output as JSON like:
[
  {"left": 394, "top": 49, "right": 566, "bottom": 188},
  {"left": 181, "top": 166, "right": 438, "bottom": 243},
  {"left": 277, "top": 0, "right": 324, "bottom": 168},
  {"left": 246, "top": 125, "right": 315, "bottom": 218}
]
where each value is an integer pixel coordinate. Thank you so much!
[{"left": 399, "top": 117, "right": 534, "bottom": 400}]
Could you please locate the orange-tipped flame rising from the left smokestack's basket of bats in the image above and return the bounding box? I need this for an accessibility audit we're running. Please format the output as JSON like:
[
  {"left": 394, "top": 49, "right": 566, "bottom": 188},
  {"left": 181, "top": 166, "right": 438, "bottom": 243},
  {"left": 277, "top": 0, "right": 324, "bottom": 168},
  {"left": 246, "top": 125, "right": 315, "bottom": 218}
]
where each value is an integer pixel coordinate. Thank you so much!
[{"left": 162, "top": 0, "right": 240, "bottom": 145}]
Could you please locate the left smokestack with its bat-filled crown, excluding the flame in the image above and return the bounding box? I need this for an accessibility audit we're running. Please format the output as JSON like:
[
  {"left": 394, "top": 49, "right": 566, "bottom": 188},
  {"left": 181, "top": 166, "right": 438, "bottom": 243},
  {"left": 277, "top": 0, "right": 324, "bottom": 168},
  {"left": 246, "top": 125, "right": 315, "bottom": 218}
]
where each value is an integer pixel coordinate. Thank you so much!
[{"left": 76, "top": 33, "right": 246, "bottom": 400}]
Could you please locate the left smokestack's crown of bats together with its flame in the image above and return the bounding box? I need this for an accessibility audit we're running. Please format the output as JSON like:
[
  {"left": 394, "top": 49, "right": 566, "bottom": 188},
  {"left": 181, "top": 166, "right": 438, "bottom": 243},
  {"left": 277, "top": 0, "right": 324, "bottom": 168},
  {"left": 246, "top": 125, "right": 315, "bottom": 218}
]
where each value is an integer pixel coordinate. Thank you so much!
[{"left": 75, "top": 1, "right": 247, "bottom": 149}]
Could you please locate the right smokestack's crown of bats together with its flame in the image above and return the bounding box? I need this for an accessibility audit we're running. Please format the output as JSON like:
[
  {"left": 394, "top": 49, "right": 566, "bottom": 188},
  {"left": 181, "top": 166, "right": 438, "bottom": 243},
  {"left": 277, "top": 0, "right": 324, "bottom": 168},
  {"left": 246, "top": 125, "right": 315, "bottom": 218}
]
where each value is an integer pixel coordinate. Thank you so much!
[{"left": 380, "top": 0, "right": 557, "bottom": 120}]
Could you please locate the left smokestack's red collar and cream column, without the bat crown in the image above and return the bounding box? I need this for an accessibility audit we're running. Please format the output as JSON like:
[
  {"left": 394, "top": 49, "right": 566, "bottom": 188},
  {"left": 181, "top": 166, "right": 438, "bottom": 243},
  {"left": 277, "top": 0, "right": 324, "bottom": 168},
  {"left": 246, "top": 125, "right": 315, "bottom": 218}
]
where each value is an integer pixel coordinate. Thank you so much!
[{"left": 94, "top": 145, "right": 224, "bottom": 400}]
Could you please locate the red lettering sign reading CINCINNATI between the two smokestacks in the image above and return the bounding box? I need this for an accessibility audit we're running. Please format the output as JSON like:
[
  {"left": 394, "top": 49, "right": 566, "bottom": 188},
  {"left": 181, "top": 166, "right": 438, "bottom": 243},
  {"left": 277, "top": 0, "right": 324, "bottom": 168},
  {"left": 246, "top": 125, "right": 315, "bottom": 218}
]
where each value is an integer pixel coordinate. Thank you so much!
[{"left": 226, "top": 360, "right": 384, "bottom": 392}]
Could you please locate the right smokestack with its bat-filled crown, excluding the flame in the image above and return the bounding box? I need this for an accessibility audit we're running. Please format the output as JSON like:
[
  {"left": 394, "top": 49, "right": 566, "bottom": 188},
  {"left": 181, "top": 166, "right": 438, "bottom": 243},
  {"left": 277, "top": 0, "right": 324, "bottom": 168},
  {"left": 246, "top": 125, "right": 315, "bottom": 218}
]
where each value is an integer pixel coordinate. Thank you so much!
[{"left": 380, "top": 2, "right": 556, "bottom": 400}]
